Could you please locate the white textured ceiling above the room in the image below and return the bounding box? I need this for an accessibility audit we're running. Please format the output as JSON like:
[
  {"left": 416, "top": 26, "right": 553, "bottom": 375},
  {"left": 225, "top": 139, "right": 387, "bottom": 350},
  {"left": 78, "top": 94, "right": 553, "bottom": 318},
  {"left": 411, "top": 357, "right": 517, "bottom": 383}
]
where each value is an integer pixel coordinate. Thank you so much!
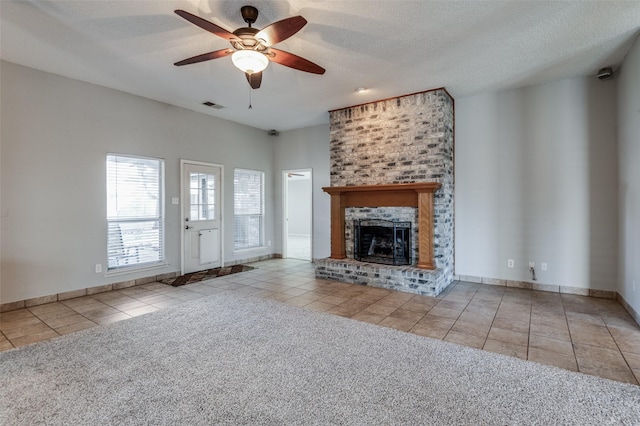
[{"left": 0, "top": 0, "right": 640, "bottom": 131}]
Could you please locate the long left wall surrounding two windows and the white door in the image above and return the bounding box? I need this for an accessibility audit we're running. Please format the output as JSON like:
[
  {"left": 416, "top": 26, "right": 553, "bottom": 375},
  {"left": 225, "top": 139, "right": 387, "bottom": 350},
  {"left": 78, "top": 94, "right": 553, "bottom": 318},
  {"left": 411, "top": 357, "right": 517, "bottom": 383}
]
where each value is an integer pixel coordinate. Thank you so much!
[{"left": 0, "top": 62, "right": 274, "bottom": 303}]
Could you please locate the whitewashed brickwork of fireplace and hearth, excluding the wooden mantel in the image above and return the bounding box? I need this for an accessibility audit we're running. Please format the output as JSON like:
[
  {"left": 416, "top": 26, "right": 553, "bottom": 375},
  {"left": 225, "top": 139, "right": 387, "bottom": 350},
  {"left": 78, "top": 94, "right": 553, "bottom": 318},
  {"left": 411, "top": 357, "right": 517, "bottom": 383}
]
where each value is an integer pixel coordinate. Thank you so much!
[{"left": 316, "top": 88, "right": 454, "bottom": 296}]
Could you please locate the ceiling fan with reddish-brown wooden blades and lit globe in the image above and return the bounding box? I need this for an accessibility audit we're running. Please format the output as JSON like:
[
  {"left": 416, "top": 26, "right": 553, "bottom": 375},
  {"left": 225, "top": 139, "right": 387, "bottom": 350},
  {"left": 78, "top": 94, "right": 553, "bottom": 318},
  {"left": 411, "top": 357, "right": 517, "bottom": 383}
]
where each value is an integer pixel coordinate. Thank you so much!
[{"left": 174, "top": 6, "right": 325, "bottom": 89}]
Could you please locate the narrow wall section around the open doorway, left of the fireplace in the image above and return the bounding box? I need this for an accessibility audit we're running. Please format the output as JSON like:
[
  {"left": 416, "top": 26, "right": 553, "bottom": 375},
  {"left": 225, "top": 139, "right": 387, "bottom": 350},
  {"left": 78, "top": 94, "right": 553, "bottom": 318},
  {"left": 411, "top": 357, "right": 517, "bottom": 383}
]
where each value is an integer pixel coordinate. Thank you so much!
[{"left": 274, "top": 124, "right": 331, "bottom": 259}]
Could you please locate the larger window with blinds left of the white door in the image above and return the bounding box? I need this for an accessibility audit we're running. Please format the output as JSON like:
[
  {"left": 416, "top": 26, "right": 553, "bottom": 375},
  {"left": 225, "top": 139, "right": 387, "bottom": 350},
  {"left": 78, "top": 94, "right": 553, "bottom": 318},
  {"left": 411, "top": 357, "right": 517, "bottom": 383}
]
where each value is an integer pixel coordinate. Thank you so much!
[{"left": 107, "top": 154, "right": 165, "bottom": 271}]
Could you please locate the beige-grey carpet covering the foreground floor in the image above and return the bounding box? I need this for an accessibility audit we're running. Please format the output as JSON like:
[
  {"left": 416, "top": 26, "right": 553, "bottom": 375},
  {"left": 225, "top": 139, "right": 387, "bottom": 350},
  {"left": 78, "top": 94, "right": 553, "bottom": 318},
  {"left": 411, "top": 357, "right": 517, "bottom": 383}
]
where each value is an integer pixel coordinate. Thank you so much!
[{"left": 0, "top": 292, "right": 640, "bottom": 425}]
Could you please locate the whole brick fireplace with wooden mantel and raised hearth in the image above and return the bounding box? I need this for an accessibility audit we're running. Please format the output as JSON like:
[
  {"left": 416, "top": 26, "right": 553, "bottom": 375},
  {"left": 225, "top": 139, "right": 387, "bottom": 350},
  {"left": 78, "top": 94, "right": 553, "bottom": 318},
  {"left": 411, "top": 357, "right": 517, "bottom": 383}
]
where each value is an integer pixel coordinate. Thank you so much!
[{"left": 316, "top": 89, "right": 454, "bottom": 296}]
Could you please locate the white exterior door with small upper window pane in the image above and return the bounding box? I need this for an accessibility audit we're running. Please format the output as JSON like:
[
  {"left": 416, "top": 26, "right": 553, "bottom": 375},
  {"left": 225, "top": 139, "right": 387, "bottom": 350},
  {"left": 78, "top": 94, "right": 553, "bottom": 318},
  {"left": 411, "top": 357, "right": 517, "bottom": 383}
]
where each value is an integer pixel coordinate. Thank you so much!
[{"left": 181, "top": 160, "right": 222, "bottom": 274}]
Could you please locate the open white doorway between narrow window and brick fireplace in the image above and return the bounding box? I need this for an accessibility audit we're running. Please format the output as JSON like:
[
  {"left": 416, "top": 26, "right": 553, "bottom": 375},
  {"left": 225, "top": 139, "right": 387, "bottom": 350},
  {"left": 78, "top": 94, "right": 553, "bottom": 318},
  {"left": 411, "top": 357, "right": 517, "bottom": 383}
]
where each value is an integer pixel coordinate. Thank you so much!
[{"left": 282, "top": 169, "right": 313, "bottom": 260}]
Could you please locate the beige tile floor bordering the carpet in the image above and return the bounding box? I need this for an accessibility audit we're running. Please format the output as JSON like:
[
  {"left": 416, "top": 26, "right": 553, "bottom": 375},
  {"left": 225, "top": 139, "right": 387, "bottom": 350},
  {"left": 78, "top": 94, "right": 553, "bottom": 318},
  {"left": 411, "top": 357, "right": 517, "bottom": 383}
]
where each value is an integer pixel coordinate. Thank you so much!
[{"left": 0, "top": 259, "right": 640, "bottom": 385}]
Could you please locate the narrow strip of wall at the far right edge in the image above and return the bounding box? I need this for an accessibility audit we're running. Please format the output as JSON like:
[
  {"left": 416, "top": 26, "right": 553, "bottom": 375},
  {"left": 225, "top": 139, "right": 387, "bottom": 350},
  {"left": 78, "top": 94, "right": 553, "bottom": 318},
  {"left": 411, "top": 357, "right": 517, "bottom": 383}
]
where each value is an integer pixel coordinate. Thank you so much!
[{"left": 618, "top": 38, "right": 640, "bottom": 313}]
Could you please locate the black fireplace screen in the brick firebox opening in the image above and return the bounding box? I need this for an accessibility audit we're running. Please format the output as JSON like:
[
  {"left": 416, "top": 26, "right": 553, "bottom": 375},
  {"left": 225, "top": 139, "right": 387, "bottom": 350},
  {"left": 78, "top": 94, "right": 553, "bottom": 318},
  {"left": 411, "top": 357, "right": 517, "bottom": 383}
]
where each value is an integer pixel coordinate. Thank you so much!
[{"left": 353, "top": 219, "right": 411, "bottom": 265}]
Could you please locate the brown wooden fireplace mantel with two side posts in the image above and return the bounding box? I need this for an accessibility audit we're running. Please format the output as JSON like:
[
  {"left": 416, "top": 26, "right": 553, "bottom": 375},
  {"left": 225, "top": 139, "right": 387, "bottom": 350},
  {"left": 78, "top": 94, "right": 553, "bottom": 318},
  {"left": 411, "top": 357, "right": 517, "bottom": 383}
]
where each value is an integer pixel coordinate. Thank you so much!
[{"left": 322, "top": 182, "right": 441, "bottom": 269}]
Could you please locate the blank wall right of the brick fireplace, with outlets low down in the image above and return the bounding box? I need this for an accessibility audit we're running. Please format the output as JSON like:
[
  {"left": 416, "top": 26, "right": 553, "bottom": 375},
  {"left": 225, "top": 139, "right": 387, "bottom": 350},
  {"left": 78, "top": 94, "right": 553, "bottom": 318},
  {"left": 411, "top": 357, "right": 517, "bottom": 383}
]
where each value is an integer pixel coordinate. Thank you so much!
[{"left": 455, "top": 77, "right": 618, "bottom": 291}]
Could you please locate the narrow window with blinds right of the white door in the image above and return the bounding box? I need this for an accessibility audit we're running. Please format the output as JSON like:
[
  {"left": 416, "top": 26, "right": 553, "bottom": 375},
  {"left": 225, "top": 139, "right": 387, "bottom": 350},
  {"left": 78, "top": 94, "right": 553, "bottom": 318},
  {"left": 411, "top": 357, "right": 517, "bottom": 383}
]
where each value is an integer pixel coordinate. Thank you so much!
[{"left": 233, "top": 169, "right": 264, "bottom": 250}]
